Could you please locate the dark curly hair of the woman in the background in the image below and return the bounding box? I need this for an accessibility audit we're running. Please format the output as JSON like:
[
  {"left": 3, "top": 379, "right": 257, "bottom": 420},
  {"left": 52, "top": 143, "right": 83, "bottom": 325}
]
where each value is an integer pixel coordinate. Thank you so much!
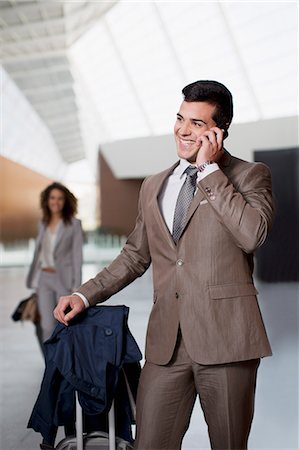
[{"left": 40, "top": 182, "right": 78, "bottom": 224}]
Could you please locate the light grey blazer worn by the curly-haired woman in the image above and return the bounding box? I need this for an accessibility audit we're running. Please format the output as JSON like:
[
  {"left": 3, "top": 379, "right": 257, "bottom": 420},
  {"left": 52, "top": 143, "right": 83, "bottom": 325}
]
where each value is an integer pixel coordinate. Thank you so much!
[{"left": 26, "top": 218, "right": 83, "bottom": 294}]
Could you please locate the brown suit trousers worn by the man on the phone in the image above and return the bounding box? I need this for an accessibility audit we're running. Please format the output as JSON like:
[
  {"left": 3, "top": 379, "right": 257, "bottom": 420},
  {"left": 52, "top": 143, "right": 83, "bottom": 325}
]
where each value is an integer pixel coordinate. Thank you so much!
[{"left": 134, "top": 333, "right": 260, "bottom": 450}]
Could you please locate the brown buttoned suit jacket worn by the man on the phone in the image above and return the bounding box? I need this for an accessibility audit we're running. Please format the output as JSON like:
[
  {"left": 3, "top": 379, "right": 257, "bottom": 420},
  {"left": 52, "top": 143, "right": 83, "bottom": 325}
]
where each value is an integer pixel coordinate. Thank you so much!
[{"left": 78, "top": 152, "right": 273, "bottom": 364}]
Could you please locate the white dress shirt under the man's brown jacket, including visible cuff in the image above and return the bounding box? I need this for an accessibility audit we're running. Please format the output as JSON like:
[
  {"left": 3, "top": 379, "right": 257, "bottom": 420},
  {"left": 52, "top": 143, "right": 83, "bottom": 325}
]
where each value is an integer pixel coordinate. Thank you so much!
[{"left": 74, "top": 159, "right": 219, "bottom": 308}]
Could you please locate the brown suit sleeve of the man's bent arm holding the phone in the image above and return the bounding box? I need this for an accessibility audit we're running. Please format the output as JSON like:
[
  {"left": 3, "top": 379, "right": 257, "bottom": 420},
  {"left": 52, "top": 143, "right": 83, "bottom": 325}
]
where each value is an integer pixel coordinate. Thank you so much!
[{"left": 199, "top": 163, "right": 274, "bottom": 253}]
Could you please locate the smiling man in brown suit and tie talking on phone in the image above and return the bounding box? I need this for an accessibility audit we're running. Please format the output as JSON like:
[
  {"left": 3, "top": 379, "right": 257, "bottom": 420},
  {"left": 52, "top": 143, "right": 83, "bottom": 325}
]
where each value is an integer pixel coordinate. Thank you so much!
[{"left": 54, "top": 80, "right": 273, "bottom": 450}]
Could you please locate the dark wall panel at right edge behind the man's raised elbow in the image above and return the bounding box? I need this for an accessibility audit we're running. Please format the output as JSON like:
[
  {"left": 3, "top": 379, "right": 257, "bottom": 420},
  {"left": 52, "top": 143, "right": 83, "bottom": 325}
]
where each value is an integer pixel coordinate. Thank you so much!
[{"left": 254, "top": 148, "right": 299, "bottom": 282}]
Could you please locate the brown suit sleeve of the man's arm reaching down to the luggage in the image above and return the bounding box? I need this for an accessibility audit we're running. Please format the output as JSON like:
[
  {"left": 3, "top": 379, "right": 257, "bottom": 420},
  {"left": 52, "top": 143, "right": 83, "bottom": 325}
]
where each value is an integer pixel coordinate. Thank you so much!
[{"left": 77, "top": 183, "right": 151, "bottom": 305}]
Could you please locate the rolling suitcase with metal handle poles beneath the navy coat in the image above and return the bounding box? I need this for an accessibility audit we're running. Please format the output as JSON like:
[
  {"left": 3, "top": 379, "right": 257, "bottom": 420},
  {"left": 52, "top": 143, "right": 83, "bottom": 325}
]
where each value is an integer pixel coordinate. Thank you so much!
[{"left": 55, "top": 375, "right": 136, "bottom": 450}]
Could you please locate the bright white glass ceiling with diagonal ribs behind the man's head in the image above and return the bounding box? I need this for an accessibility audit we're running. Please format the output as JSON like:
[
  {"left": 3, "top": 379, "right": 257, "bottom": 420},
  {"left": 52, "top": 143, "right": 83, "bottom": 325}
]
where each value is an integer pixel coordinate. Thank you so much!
[{"left": 70, "top": 1, "right": 298, "bottom": 149}]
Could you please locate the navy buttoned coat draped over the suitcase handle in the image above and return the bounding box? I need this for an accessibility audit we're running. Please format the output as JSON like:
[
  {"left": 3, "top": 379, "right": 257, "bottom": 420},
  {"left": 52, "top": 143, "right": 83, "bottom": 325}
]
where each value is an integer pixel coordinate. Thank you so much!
[{"left": 28, "top": 305, "right": 142, "bottom": 442}]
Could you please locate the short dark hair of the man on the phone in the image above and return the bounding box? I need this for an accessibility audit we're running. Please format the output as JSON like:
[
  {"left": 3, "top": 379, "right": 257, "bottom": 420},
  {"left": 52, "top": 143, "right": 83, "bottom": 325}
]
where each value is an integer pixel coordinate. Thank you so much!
[{"left": 182, "top": 80, "right": 233, "bottom": 137}]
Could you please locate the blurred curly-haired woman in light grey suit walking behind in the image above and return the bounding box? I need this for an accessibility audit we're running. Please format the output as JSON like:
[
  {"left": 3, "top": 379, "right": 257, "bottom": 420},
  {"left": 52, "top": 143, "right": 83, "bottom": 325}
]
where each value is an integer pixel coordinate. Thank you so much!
[{"left": 26, "top": 182, "right": 83, "bottom": 348}]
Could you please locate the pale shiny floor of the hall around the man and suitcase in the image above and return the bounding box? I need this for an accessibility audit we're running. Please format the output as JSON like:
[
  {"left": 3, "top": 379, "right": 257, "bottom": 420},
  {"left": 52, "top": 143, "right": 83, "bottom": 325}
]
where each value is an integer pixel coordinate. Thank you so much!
[{"left": 0, "top": 265, "right": 299, "bottom": 450}]
